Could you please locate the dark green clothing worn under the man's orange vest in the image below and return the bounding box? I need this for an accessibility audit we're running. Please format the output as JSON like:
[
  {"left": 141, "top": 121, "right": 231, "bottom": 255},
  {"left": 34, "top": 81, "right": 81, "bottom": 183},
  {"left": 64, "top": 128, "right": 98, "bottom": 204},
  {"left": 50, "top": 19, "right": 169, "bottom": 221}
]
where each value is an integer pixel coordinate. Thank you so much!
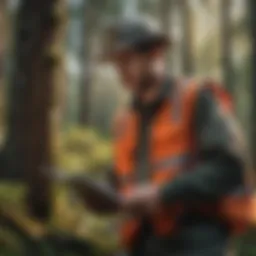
[{"left": 115, "top": 79, "right": 244, "bottom": 256}]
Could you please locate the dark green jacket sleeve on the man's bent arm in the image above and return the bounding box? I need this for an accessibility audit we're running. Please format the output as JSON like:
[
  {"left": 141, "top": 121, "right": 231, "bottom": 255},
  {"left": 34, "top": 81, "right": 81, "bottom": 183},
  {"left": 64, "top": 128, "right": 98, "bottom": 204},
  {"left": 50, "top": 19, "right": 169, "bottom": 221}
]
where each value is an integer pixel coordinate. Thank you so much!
[{"left": 160, "top": 89, "right": 245, "bottom": 204}]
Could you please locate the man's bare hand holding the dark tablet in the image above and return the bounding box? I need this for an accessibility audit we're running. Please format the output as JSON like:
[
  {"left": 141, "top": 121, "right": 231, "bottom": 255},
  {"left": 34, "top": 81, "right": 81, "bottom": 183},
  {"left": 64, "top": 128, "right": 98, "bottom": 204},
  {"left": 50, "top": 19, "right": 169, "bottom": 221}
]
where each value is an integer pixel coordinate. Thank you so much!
[{"left": 121, "top": 185, "right": 159, "bottom": 215}]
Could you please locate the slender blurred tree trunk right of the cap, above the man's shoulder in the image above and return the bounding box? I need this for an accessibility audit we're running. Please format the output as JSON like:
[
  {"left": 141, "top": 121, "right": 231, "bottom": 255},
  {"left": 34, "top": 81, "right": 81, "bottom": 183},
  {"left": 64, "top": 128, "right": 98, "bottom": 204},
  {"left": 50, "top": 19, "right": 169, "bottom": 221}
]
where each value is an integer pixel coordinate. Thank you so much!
[{"left": 178, "top": 0, "right": 194, "bottom": 75}]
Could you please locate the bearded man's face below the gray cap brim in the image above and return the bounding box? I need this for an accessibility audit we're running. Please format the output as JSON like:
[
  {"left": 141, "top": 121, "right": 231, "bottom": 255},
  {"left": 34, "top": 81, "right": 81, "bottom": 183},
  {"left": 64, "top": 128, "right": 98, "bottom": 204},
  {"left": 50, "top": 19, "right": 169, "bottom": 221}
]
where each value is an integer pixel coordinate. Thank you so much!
[{"left": 113, "top": 47, "right": 164, "bottom": 92}]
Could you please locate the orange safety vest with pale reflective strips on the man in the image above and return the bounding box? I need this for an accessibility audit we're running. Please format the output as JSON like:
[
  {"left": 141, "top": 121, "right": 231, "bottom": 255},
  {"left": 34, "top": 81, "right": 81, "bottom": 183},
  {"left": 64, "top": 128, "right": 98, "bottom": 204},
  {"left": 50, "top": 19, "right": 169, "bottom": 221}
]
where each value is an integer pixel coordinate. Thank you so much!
[{"left": 114, "top": 80, "right": 256, "bottom": 248}]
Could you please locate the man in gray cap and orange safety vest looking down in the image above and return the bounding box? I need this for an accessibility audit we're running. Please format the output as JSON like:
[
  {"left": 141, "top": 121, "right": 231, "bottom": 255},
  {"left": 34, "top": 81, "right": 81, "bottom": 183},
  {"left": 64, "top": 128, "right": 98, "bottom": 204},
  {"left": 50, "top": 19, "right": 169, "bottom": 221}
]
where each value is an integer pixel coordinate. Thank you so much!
[{"left": 86, "top": 20, "right": 254, "bottom": 256}]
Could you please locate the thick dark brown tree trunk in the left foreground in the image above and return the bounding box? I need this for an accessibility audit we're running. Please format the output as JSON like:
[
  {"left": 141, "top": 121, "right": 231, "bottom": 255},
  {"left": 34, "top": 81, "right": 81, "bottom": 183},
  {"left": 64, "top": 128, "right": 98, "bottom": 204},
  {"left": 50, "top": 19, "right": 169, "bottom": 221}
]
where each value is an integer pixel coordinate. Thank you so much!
[{"left": 5, "top": 0, "right": 63, "bottom": 220}]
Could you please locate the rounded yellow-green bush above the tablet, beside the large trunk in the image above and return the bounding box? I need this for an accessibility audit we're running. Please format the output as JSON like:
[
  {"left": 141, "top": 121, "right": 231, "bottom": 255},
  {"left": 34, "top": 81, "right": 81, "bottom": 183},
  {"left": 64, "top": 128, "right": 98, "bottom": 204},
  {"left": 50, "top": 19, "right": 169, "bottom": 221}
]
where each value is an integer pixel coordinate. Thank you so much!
[{"left": 56, "top": 127, "right": 111, "bottom": 176}]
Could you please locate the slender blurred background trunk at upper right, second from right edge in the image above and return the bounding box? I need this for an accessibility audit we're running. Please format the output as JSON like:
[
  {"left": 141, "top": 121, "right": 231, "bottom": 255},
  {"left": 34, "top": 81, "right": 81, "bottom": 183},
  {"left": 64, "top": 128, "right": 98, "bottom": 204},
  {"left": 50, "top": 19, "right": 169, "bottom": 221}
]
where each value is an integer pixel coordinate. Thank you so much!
[{"left": 220, "top": 0, "right": 234, "bottom": 93}]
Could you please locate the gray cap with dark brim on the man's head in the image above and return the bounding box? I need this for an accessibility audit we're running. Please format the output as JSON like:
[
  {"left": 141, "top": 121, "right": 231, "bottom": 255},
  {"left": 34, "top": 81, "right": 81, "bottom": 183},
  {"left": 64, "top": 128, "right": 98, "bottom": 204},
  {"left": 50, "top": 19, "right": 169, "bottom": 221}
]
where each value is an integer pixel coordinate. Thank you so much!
[{"left": 103, "top": 16, "right": 170, "bottom": 59}]
